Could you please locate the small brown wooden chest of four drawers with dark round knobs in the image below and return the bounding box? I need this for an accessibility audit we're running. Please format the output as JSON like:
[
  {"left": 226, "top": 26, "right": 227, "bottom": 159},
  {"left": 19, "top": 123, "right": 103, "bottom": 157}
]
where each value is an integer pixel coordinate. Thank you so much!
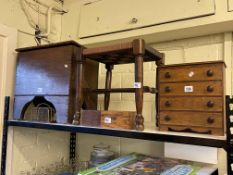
[{"left": 158, "top": 61, "right": 225, "bottom": 135}]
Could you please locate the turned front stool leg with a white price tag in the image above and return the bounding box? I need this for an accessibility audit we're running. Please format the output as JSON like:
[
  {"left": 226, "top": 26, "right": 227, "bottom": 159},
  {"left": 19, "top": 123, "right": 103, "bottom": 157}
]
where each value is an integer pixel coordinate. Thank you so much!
[{"left": 135, "top": 55, "right": 144, "bottom": 131}]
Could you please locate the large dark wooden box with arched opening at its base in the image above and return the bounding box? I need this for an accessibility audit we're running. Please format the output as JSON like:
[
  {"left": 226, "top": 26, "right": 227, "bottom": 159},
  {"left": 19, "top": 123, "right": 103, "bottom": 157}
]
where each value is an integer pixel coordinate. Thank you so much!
[{"left": 13, "top": 41, "right": 99, "bottom": 123}]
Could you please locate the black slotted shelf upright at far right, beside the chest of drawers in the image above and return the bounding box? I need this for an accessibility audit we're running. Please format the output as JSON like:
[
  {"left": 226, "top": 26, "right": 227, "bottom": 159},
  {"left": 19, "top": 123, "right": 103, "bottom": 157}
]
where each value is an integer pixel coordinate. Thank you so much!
[{"left": 225, "top": 96, "right": 233, "bottom": 175}]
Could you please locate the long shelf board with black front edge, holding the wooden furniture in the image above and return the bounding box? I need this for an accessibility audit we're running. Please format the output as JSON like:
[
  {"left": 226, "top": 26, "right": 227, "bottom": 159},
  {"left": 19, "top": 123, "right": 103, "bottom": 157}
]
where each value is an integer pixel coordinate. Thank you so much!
[{"left": 7, "top": 120, "right": 227, "bottom": 149}]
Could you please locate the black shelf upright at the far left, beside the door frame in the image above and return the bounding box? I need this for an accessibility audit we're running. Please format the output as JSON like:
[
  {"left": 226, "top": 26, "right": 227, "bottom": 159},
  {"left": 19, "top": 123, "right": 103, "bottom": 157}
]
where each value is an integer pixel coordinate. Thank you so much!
[{"left": 1, "top": 96, "right": 10, "bottom": 175}]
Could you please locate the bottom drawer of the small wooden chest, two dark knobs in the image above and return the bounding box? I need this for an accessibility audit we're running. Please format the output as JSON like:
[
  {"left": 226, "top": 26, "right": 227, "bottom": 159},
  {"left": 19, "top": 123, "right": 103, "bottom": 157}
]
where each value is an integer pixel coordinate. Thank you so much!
[{"left": 160, "top": 111, "right": 223, "bottom": 128}]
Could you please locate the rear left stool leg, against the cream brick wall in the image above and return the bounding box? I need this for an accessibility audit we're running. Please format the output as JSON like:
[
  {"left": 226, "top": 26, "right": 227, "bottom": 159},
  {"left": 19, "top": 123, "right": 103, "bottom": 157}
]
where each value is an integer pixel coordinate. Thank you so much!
[{"left": 104, "top": 64, "right": 113, "bottom": 110}]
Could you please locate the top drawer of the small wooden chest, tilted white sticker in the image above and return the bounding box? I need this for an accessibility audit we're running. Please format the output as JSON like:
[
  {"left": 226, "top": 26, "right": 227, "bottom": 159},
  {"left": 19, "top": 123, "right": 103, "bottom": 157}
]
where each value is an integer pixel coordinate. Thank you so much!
[{"left": 159, "top": 62, "right": 224, "bottom": 82}]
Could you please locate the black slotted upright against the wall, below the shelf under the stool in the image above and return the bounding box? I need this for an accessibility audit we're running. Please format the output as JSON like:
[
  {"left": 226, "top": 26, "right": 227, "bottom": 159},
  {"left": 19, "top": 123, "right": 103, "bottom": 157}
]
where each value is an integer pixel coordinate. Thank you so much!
[{"left": 70, "top": 132, "right": 77, "bottom": 171}]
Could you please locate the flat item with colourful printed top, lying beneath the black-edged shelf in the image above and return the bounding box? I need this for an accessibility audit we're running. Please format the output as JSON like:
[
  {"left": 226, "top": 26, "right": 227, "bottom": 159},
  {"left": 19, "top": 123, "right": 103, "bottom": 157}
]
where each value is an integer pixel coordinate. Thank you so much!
[{"left": 78, "top": 153, "right": 217, "bottom": 175}]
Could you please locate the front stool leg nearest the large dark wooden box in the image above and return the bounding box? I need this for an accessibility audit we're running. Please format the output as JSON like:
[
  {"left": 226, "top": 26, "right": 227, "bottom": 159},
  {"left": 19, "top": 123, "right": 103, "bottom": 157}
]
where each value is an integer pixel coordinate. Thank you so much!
[{"left": 73, "top": 63, "right": 83, "bottom": 125}]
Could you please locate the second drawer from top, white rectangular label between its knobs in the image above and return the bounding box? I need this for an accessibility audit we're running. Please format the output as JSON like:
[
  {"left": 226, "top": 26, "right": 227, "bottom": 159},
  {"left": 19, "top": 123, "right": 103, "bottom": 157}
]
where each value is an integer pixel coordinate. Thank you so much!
[{"left": 159, "top": 81, "right": 223, "bottom": 96}]
